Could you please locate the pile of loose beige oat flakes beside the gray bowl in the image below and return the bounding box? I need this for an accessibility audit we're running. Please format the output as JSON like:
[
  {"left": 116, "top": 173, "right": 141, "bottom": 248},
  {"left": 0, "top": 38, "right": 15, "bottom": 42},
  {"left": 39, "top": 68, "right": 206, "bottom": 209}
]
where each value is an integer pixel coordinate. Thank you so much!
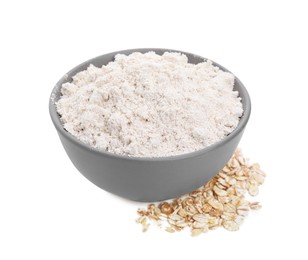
[{"left": 137, "top": 150, "right": 265, "bottom": 236}]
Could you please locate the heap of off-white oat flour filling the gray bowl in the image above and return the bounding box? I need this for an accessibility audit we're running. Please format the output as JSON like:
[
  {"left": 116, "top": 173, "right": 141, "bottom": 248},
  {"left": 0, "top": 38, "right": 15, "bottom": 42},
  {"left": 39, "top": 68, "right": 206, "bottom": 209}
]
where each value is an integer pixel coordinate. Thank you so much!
[{"left": 56, "top": 52, "right": 243, "bottom": 157}]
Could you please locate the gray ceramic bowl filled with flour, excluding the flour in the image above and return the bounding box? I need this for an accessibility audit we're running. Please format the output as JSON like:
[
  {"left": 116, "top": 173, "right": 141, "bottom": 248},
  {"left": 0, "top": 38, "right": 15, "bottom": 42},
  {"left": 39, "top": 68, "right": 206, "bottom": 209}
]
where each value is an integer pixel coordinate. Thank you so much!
[{"left": 49, "top": 49, "right": 251, "bottom": 201}]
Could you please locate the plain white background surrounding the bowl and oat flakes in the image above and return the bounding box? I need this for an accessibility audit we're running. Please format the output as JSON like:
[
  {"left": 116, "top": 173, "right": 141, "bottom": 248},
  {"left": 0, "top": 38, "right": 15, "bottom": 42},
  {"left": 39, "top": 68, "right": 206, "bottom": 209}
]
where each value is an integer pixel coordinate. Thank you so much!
[{"left": 0, "top": 0, "right": 308, "bottom": 260}]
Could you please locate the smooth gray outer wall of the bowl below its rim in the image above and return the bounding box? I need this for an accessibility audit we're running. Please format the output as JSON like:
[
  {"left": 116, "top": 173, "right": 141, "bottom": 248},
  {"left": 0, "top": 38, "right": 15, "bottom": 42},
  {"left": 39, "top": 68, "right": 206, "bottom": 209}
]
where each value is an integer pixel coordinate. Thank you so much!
[{"left": 60, "top": 132, "right": 242, "bottom": 201}]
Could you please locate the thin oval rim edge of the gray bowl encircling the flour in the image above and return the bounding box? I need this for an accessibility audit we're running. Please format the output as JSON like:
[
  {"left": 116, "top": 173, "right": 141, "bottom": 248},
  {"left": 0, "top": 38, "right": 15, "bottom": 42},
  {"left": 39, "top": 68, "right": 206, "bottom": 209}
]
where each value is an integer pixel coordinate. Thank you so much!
[{"left": 49, "top": 48, "right": 251, "bottom": 162}]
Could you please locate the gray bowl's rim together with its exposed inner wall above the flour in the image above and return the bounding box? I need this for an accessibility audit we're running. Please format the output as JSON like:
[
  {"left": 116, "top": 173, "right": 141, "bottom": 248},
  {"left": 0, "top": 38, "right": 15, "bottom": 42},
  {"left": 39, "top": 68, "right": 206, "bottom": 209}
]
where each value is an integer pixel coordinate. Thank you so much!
[{"left": 49, "top": 48, "right": 251, "bottom": 161}]
